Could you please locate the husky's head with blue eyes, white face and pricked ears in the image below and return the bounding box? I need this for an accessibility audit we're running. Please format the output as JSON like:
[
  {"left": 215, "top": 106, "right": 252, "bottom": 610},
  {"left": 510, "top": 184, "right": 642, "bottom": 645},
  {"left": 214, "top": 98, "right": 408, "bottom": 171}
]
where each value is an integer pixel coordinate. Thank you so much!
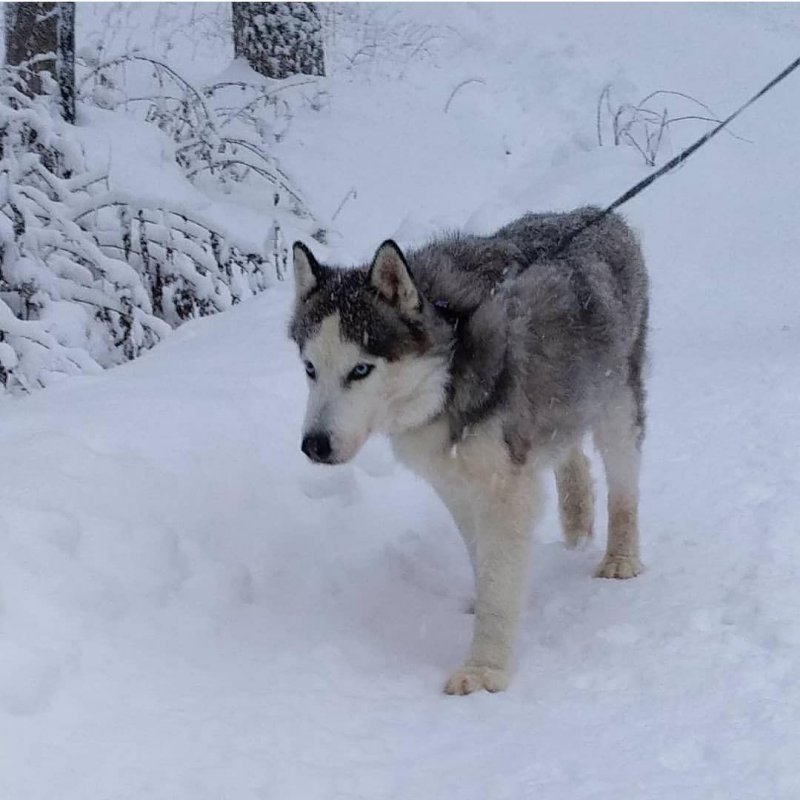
[{"left": 290, "top": 241, "right": 447, "bottom": 464}]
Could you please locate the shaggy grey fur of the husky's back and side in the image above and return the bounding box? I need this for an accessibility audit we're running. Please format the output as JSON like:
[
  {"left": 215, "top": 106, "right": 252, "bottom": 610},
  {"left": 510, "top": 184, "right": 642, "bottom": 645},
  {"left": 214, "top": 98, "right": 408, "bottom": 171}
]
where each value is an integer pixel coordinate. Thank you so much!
[{"left": 408, "top": 207, "right": 647, "bottom": 460}]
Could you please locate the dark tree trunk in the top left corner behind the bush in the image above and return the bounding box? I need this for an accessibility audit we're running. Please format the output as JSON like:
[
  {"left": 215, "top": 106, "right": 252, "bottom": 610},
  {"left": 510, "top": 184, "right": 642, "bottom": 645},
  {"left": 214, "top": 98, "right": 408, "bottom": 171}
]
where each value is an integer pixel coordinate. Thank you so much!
[{"left": 5, "top": 3, "right": 75, "bottom": 122}]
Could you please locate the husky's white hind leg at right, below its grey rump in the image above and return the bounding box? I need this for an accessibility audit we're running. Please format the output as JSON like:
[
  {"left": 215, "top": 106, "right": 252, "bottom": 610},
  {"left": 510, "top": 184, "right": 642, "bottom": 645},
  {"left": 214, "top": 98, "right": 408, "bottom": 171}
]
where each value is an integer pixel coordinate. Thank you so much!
[{"left": 594, "top": 385, "right": 643, "bottom": 578}]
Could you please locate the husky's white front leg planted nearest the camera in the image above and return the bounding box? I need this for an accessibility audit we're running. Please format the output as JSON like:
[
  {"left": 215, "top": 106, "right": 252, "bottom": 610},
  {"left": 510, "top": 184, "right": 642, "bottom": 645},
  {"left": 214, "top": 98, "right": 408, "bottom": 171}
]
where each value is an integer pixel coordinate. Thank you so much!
[{"left": 445, "top": 476, "right": 537, "bottom": 694}]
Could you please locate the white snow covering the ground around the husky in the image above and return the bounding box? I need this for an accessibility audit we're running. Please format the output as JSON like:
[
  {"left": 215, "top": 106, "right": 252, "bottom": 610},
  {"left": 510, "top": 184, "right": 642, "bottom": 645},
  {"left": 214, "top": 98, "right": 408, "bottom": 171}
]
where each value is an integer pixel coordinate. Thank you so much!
[{"left": 0, "top": 5, "right": 800, "bottom": 800}]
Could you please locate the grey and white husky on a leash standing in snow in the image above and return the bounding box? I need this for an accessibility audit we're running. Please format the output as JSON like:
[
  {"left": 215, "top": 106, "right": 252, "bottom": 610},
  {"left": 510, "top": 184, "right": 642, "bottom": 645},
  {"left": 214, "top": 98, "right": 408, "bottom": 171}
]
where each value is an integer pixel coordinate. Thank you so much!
[{"left": 290, "top": 208, "right": 648, "bottom": 694}]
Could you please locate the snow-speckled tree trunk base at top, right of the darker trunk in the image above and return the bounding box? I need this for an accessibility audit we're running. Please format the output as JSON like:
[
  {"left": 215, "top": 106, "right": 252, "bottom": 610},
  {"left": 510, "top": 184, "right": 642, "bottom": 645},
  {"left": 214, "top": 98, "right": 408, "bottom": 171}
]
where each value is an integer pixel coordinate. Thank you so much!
[{"left": 231, "top": 3, "right": 325, "bottom": 78}]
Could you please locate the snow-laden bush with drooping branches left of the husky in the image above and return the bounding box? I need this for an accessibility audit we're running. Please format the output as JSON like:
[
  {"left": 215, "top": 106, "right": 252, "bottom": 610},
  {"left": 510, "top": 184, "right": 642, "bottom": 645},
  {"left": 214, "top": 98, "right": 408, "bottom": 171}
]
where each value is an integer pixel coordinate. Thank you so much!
[{"left": 0, "top": 69, "right": 278, "bottom": 391}]
